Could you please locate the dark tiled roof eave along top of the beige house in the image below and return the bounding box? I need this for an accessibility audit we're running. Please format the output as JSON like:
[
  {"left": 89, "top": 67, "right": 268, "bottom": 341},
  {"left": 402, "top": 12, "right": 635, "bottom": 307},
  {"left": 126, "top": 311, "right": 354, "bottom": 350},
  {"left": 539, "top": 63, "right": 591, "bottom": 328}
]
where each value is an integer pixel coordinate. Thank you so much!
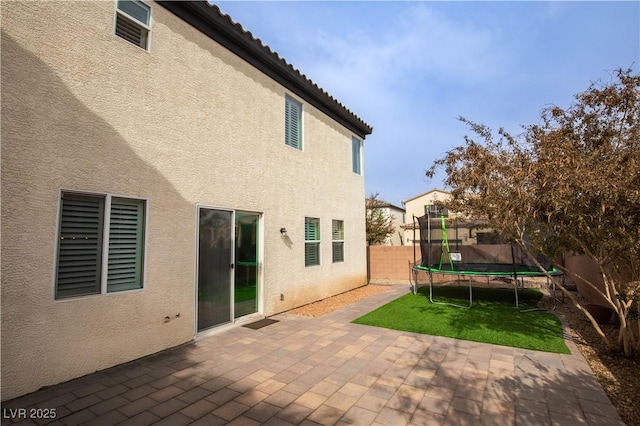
[{"left": 158, "top": 0, "right": 373, "bottom": 138}]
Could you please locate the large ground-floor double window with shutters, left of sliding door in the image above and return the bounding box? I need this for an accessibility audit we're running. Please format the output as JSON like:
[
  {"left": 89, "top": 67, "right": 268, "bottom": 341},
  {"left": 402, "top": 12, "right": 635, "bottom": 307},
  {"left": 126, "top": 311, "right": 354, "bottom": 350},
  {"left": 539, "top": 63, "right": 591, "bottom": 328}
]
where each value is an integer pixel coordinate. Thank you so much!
[{"left": 55, "top": 192, "right": 146, "bottom": 299}]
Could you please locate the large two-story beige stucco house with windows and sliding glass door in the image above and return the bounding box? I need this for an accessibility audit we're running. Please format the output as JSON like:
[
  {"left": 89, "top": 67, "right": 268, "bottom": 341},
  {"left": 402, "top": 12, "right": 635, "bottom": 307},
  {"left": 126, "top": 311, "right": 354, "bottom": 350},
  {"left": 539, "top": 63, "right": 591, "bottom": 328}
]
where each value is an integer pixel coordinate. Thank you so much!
[{"left": 0, "top": 0, "right": 372, "bottom": 400}]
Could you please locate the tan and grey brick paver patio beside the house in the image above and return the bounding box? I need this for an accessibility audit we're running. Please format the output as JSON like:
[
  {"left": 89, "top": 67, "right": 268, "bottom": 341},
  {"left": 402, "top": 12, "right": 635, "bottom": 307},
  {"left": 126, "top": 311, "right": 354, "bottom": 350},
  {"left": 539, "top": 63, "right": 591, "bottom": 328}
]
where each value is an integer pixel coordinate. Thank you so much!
[{"left": 2, "top": 286, "right": 624, "bottom": 426}]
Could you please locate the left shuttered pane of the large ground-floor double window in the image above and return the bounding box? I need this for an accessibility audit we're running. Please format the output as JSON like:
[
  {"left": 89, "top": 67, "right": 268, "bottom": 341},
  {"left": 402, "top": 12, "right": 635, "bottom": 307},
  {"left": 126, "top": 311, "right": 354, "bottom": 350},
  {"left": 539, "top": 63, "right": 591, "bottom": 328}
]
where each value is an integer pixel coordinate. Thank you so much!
[{"left": 56, "top": 194, "right": 104, "bottom": 299}]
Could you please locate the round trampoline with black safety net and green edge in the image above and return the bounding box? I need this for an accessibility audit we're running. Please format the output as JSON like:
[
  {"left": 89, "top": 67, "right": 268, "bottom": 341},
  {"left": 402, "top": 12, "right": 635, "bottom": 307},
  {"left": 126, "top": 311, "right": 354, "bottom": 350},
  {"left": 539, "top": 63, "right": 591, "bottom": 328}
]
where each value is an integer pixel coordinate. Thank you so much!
[{"left": 411, "top": 212, "right": 562, "bottom": 312}]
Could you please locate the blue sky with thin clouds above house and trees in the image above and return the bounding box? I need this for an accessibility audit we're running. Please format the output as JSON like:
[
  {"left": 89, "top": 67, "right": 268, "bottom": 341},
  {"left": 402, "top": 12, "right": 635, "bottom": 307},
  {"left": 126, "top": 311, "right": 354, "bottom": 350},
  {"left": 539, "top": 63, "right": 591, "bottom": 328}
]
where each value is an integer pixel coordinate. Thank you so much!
[{"left": 214, "top": 1, "right": 640, "bottom": 206}]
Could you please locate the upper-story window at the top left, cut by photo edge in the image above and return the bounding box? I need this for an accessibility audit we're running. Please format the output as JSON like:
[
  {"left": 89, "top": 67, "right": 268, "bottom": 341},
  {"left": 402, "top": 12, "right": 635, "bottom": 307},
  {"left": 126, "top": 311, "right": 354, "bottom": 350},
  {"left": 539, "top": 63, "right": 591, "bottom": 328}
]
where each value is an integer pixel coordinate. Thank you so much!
[{"left": 116, "top": 0, "right": 151, "bottom": 50}]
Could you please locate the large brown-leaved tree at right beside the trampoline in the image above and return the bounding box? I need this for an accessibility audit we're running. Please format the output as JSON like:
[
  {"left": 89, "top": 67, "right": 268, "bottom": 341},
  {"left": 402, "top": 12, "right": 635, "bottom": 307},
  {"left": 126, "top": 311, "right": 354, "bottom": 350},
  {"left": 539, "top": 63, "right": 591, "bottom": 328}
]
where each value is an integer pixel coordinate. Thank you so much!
[{"left": 427, "top": 70, "right": 640, "bottom": 356}]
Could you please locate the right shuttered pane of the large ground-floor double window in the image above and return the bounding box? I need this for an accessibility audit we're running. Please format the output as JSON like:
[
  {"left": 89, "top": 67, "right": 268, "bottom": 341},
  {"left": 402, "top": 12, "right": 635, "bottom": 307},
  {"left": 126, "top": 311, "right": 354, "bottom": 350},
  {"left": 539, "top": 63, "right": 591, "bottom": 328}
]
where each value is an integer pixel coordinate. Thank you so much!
[{"left": 107, "top": 198, "right": 144, "bottom": 293}]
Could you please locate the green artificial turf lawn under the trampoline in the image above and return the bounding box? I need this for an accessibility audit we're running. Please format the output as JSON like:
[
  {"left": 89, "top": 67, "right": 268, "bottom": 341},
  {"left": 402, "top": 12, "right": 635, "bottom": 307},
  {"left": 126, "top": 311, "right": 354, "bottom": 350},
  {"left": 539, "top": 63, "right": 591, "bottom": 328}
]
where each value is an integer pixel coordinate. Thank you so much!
[{"left": 353, "top": 287, "right": 570, "bottom": 354}]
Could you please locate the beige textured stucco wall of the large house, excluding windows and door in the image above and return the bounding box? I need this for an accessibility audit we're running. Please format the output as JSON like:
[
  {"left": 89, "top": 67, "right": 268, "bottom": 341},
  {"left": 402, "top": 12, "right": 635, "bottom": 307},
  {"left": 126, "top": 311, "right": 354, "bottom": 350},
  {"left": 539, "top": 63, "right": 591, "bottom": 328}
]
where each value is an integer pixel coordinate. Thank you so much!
[{"left": 0, "top": 1, "right": 366, "bottom": 400}]
